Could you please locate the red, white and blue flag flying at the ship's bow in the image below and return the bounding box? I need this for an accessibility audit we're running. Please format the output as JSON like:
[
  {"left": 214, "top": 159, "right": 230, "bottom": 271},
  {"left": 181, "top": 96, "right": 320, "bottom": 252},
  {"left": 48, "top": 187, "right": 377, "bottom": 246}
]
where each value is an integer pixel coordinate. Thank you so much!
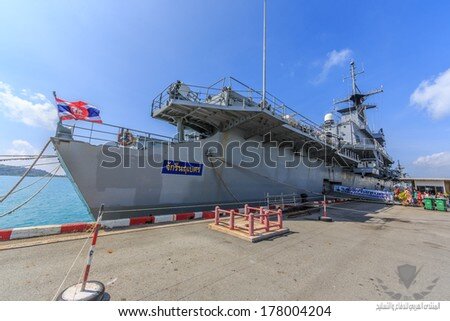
[{"left": 55, "top": 96, "right": 102, "bottom": 123}]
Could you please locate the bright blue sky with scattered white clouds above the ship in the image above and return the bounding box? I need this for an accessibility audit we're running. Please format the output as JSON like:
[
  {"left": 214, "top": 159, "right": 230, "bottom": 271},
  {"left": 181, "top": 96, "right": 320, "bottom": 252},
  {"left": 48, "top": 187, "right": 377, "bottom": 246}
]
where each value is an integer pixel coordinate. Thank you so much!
[{"left": 0, "top": 0, "right": 450, "bottom": 177}]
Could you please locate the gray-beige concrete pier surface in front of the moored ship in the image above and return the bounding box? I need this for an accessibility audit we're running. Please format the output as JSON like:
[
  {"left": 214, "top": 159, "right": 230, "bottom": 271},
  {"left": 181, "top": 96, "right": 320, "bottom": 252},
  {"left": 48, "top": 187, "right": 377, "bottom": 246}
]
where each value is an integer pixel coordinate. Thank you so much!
[{"left": 0, "top": 203, "right": 450, "bottom": 300}]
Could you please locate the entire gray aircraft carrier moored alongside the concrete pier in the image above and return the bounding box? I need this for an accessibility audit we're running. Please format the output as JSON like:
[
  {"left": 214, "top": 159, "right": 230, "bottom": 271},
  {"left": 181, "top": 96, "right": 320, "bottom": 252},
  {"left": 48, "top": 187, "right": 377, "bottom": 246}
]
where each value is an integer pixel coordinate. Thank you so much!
[{"left": 52, "top": 64, "right": 395, "bottom": 218}]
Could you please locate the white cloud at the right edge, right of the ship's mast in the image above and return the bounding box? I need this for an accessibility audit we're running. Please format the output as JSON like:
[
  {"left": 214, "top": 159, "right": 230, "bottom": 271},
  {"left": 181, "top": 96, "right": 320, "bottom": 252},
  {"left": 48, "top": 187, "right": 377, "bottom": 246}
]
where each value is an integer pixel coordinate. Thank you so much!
[{"left": 410, "top": 69, "right": 450, "bottom": 119}]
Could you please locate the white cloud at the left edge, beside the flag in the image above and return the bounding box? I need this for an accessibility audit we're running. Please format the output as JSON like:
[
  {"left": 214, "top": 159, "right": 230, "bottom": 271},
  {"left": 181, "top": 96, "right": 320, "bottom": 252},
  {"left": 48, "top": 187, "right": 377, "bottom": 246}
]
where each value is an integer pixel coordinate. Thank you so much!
[{"left": 0, "top": 81, "right": 58, "bottom": 129}]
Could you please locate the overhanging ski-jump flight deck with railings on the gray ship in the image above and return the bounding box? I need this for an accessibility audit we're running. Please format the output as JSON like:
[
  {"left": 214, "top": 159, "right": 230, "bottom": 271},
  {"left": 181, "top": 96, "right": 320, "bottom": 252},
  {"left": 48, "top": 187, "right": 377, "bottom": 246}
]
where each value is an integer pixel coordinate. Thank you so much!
[{"left": 151, "top": 77, "right": 359, "bottom": 167}]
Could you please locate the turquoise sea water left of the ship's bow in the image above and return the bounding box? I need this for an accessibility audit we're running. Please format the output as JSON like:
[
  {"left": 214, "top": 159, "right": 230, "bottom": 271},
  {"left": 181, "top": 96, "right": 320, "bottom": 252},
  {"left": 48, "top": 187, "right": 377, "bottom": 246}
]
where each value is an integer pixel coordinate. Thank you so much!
[{"left": 0, "top": 176, "right": 92, "bottom": 229}]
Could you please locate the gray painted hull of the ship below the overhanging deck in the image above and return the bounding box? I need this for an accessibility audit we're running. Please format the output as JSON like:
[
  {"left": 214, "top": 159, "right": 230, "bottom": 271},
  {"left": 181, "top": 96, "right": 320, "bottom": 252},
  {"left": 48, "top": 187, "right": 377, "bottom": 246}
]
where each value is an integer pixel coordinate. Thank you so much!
[{"left": 52, "top": 129, "right": 391, "bottom": 219}]
